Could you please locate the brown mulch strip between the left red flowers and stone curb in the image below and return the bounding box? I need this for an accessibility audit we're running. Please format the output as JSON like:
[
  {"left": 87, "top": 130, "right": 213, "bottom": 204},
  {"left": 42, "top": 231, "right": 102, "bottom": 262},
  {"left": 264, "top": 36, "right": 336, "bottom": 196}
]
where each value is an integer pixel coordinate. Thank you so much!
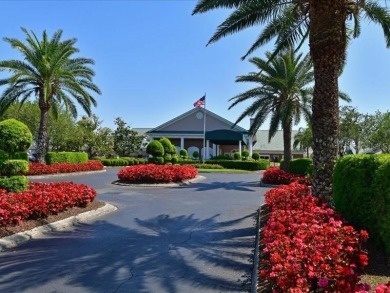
[{"left": 0, "top": 200, "right": 105, "bottom": 238}]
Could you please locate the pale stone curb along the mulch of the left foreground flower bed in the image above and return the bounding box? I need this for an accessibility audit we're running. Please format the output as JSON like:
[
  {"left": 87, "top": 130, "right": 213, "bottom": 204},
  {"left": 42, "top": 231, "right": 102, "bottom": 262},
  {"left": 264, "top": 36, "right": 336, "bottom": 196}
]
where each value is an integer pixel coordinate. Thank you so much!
[{"left": 0, "top": 203, "right": 117, "bottom": 251}]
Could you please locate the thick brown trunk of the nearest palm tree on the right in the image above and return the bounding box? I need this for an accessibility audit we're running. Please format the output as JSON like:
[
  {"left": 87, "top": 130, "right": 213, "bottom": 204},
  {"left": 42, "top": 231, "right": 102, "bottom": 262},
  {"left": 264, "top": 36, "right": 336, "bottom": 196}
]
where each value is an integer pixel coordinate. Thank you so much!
[{"left": 309, "top": 0, "right": 347, "bottom": 203}]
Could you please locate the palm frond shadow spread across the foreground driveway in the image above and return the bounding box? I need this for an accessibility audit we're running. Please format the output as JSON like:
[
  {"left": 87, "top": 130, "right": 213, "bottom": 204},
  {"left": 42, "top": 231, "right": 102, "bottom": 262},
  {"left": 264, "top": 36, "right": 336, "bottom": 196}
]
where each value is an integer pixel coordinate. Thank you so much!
[{"left": 0, "top": 214, "right": 256, "bottom": 292}]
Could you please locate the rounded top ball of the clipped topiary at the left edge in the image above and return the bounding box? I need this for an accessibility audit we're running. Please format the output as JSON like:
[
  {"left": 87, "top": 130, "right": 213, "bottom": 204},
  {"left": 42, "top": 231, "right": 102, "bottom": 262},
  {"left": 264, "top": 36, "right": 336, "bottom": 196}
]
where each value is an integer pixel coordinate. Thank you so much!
[{"left": 0, "top": 119, "right": 32, "bottom": 157}]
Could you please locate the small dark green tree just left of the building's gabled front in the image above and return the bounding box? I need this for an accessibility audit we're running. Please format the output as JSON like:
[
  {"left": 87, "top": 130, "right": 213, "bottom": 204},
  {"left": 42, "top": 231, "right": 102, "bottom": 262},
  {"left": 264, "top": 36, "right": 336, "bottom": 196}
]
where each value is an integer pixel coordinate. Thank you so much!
[{"left": 114, "top": 117, "right": 145, "bottom": 157}]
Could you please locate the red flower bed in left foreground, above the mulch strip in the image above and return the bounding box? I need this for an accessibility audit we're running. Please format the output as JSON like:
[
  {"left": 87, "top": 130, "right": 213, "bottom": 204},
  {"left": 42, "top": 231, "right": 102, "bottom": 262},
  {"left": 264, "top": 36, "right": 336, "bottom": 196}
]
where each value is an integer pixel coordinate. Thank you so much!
[{"left": 0, "top": 182, "right": 96, "bottom": 226}]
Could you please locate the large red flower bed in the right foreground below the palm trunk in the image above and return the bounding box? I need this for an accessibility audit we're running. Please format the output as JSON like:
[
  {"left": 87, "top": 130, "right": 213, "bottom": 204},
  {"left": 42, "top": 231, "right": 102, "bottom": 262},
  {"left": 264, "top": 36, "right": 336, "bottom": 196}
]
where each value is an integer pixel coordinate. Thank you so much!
[{"left": 260, "top": 183, "right": 368, "bottom": 292}]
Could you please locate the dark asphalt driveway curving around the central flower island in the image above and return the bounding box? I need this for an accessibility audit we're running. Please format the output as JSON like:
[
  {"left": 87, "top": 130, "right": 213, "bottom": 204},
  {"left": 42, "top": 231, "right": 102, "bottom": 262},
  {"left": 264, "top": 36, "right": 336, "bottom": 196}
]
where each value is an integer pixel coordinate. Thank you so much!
[{"left": 0, "top": 169, "right": 265, "bottom": 293}]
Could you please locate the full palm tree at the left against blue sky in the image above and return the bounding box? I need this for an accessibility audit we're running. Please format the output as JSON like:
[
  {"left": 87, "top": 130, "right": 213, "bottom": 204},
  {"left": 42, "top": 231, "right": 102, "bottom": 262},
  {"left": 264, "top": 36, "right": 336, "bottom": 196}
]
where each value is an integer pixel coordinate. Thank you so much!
[{"left": 0, "top": 28, "right": 100, "bottom": 162}]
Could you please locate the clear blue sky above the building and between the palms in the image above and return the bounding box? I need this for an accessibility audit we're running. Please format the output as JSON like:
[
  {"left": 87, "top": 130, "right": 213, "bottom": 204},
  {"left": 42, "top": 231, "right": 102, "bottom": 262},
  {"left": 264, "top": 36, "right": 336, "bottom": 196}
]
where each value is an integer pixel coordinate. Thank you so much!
[{"left": 0, "top": 0, "right": 390, "bottom": 129}]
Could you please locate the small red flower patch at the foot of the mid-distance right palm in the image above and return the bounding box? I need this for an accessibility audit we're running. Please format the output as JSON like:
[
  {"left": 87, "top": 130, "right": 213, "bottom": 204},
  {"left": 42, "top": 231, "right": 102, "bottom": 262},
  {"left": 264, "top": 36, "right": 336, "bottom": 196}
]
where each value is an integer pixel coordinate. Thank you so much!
[{"left": 261, "top": 167, "right": 311, "bottom": 185}]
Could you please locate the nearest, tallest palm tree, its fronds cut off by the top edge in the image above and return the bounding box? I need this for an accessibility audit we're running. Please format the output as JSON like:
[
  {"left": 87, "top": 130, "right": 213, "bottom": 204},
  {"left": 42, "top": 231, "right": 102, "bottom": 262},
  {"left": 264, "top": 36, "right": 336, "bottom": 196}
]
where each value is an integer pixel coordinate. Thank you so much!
[{"left": 193, "top": 0, "right": 390, "bottom": 201}]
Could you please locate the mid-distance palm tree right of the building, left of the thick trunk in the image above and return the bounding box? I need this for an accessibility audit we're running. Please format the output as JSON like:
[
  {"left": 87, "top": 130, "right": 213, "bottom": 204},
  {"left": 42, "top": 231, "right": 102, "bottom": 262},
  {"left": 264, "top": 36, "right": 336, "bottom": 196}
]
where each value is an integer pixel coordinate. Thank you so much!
[{"left": 229, "top": 49, "right": 314, "bottom": 171}]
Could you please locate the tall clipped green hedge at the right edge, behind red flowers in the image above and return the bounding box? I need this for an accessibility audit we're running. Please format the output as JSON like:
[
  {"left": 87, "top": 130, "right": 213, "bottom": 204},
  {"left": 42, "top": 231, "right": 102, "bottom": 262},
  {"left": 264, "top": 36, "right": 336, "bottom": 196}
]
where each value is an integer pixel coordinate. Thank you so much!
[{"left": 333, "top": 154, "right": 390, "bottom": 255}]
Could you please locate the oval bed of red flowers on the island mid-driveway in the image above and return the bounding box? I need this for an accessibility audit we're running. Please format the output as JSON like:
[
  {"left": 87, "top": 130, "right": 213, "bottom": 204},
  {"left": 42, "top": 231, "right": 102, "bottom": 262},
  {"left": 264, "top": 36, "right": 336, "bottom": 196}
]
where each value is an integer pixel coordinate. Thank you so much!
[{"left": 118, "top": 164, "right": 198, "bottom": 183}]
